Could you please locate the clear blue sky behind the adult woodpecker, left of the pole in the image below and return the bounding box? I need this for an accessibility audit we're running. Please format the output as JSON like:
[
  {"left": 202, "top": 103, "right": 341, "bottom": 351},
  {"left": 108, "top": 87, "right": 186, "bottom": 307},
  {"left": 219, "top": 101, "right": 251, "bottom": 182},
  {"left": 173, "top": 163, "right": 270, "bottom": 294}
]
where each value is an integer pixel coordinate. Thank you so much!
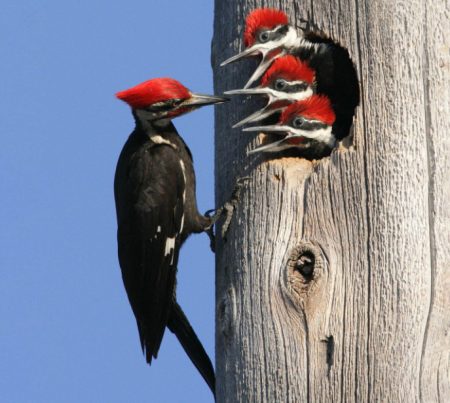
[{"left": 0, "top": 0, "right": 218, "bottom": 403}]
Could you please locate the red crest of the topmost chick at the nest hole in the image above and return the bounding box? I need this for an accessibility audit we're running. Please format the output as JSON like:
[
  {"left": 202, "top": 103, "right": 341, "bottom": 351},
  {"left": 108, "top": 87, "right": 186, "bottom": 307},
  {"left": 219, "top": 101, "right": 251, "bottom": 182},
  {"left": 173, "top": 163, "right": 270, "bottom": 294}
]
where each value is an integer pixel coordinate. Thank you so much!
[{"left": 244, "top": 8, "right": 288, "bottom": 47}]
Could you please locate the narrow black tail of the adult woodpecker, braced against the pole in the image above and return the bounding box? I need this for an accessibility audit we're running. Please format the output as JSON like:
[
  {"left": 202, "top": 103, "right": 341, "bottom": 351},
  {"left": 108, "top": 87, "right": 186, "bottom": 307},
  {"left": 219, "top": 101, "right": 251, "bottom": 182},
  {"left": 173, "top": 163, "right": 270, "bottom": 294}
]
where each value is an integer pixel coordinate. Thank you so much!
[{"left": 167, "top": 301, "right": 216, "bottom": 396}]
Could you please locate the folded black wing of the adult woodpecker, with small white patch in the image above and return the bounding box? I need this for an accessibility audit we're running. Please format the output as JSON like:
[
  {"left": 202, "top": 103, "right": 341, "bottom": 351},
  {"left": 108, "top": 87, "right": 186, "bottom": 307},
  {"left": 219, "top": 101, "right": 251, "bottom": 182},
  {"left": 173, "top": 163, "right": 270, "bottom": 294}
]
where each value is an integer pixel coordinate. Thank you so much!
[{"left": 115, "top": 132, "right": 185, "bottom": 363}]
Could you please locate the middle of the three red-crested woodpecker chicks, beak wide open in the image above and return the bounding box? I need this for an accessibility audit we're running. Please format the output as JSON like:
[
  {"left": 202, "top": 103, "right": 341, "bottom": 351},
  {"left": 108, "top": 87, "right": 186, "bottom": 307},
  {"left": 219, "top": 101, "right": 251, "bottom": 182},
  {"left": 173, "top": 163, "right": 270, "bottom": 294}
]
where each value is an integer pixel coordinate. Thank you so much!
[{"left": 225, "top": 55, "right": 315, "bottom": 128}]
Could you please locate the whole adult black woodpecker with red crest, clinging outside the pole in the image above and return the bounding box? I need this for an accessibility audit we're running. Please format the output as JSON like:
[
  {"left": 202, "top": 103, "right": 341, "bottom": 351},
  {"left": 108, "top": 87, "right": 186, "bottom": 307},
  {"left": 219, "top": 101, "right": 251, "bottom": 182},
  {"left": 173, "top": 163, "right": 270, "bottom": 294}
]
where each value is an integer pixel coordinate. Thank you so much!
[{"left": 114, "top": 78, "right": 226, "bottom": 393}]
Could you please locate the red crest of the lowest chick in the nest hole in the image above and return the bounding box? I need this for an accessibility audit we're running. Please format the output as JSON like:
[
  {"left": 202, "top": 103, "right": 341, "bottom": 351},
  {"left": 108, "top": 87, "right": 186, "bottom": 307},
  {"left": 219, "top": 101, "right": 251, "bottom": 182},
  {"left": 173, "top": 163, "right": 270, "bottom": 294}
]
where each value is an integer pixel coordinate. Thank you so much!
[{"left": 280, "top": 95, "right": 336, "bottom": 126}]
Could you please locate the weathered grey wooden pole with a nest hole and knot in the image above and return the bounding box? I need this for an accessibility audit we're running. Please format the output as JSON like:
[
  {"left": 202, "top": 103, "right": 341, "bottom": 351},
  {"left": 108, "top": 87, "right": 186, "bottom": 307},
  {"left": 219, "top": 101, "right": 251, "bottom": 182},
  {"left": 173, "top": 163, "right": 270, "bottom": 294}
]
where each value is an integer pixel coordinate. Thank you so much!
[{"left": 212, "top": 0, "right": 450, "bottom": 403}]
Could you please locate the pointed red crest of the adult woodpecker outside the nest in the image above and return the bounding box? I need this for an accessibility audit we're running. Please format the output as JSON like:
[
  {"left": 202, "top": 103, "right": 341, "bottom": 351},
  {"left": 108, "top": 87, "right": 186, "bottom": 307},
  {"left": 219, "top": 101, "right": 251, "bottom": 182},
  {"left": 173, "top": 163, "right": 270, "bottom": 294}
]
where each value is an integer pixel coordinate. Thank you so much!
[{"left": 116, "top": 78, "right": 191, "bottom": 109}]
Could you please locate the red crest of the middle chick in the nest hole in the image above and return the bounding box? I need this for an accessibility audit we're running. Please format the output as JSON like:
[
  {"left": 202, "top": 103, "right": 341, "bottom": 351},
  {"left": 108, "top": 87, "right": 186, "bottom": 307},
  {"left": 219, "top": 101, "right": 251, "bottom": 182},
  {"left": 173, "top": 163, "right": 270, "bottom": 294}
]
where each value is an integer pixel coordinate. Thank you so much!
[{"left": 261, "top": 55, "right": 315, "bottom": 87}]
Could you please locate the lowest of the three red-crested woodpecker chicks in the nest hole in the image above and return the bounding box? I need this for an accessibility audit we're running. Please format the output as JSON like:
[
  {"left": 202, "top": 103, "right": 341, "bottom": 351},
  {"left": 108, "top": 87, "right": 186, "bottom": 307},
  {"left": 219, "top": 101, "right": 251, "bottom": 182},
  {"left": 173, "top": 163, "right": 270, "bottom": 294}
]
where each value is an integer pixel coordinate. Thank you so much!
[{"left": 244, "top": 95, "right": 336, "bottom": 154}]
